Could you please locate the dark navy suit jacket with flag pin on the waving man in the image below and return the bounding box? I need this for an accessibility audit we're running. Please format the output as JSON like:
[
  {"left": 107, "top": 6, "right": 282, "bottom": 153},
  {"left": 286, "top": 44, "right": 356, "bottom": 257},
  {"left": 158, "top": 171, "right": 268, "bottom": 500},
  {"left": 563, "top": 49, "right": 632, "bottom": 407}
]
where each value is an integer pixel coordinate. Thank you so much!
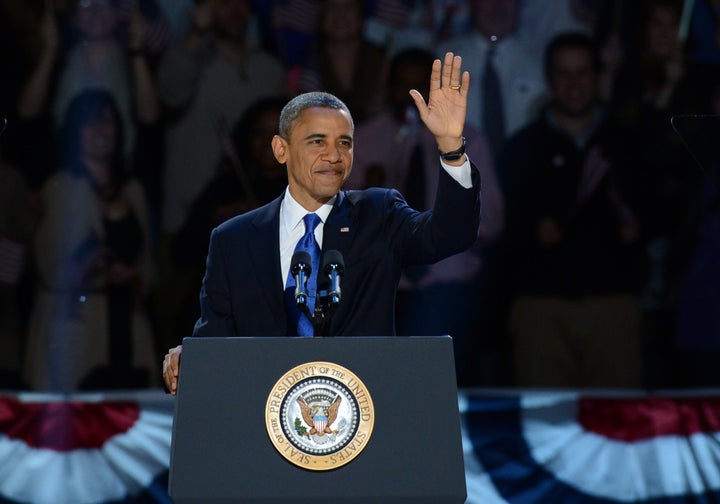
[{"left": 193, "top": 165, "right": 480, "bottom": 336}]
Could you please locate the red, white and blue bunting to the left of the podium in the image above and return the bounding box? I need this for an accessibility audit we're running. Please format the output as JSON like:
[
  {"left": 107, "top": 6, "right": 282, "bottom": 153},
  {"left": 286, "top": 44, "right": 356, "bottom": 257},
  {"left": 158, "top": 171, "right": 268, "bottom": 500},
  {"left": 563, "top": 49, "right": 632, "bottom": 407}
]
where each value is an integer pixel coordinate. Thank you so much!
[{"left": 0, "top": 394, "right": 172, "bottom": 504}]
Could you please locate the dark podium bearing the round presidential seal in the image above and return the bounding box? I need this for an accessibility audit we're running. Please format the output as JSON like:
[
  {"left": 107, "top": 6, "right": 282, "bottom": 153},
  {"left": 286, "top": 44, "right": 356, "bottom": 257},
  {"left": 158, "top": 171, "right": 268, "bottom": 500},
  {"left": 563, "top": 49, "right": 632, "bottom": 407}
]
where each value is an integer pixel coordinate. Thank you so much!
[{"left": 169, "top": 336, "right": 466, "bottom": 504}]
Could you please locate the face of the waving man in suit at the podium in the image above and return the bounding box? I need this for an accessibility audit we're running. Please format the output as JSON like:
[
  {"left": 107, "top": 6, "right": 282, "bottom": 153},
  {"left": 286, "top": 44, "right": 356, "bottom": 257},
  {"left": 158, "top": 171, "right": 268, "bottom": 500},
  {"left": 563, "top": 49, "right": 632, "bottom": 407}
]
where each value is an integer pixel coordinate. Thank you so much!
[{"left": 272, "top": 107, "right": 353, "bottom": 212}]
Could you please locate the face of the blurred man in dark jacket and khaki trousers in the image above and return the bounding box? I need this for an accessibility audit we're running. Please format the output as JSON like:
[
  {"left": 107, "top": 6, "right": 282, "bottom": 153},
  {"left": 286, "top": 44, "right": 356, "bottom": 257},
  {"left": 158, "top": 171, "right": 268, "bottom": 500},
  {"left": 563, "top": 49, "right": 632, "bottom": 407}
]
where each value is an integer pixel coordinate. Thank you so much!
[{"left": 549, "top": 48, "right": 597, "bottom": 116}]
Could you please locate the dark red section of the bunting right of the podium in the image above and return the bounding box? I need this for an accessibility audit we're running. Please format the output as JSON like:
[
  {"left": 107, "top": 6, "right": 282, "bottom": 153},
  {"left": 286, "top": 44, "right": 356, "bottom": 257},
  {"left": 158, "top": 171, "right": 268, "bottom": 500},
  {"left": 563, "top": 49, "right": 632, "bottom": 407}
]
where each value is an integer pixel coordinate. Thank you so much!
[{"left": 578, "top": 397, "right": 720, "bottom": 442}]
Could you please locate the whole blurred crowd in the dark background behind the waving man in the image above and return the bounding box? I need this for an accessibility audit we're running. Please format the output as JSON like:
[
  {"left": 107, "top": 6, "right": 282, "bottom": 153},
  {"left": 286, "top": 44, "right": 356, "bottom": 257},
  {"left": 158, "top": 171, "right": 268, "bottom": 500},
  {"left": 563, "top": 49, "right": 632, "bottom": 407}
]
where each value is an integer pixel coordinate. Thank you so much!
[{"left": 0, "top": 0, "right": 720, "bottom": 392}]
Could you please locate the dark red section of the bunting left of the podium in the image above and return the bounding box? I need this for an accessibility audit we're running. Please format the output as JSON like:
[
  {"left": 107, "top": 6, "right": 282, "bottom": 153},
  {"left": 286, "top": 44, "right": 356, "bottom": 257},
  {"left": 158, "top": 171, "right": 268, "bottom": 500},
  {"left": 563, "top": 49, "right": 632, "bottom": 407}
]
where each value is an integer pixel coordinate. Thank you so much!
[{"left": 0, "top": 397, "right": 140, "bottom": 452}]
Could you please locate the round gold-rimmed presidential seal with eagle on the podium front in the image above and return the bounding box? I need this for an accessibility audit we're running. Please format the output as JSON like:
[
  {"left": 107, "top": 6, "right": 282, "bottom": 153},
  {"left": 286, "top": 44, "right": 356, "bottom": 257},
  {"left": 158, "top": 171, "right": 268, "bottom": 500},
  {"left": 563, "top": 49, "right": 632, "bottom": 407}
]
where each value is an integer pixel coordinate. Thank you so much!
[{"left": 265, "top": 362, "right": 375, "bottom": 471}]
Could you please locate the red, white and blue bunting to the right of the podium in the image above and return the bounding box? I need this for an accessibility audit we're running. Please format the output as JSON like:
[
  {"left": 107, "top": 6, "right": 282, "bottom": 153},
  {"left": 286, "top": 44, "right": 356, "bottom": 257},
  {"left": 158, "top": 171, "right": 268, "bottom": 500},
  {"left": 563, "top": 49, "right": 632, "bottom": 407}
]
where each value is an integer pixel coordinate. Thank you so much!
[{"left": 460, "top": 392, "right": 720, "bottom": 504}]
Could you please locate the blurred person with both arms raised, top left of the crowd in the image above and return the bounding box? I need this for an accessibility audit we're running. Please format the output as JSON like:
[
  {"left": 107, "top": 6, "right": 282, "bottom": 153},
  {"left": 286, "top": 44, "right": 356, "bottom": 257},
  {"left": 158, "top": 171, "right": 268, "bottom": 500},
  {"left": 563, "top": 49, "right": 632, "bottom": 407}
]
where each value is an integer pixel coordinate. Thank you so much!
[{"left": 17, "top": 0, "right": 160, "bottom": 188}]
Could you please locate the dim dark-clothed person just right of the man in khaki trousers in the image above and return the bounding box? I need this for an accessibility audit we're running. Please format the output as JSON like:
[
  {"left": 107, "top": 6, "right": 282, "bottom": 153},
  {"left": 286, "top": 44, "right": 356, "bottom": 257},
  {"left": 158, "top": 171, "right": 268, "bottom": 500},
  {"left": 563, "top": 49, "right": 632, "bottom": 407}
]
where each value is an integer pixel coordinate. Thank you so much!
[{"left": 609, "top": 0, "right": 712, "bottom": 387}]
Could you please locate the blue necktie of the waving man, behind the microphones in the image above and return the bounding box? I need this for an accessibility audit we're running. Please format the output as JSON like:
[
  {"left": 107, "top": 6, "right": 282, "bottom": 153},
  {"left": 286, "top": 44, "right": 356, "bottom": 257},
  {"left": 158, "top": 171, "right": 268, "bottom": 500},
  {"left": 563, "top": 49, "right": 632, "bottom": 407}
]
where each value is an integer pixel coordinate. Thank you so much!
[{"left": 285, "top": 213, "right": 321, "bottom": 337}]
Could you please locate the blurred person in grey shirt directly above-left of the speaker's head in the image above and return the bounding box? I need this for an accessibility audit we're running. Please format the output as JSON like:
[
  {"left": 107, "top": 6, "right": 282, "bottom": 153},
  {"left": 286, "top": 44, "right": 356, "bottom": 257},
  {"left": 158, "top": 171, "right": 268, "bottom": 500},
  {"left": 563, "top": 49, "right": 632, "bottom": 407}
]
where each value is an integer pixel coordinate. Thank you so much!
[{"left": 158, "top": 0, "right": 285, "bottom": 238}]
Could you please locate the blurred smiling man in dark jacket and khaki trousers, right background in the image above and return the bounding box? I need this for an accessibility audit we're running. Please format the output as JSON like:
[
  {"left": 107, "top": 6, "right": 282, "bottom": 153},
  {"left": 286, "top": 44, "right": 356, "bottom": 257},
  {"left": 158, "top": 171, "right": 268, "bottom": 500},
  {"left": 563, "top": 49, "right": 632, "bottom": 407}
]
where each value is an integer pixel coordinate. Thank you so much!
[{"left": 499, "top": 32, "right": 646, "bottom": 388}]
